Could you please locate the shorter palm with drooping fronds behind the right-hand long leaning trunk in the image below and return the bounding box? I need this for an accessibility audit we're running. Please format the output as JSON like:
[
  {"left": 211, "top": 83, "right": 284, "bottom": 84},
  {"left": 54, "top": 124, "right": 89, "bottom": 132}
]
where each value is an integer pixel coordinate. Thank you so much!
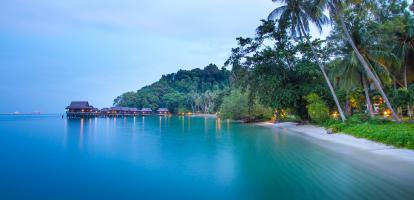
[{"left": 329, "top": 28, "right": 399, "bottom": 116}]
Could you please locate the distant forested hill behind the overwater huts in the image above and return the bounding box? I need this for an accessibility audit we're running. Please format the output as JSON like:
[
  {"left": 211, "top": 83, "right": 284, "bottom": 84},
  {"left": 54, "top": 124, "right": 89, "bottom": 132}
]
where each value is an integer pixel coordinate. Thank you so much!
[{"left": 114, "top": 64, "right": 230, "bottom": 113}]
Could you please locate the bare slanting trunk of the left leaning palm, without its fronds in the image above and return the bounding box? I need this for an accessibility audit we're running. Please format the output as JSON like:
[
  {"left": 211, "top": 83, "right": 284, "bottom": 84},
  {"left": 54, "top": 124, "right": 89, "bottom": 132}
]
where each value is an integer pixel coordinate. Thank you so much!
[{"left": 299, "top": 20, "right": 346, "bottom": 122}]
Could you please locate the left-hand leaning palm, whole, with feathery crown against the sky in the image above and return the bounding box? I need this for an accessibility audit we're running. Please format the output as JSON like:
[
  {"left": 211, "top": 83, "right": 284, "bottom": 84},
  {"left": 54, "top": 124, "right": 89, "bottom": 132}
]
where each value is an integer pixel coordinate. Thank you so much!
[{"left": 268, "top": 0, "right": 346, "bottom": 121}]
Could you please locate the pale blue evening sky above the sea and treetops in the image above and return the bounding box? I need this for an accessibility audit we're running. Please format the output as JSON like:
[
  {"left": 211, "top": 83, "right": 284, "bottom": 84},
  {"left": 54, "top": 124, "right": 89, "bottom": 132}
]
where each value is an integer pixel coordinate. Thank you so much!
[{"left": 0, "top": 0, "right": 330, "bottom": 113}]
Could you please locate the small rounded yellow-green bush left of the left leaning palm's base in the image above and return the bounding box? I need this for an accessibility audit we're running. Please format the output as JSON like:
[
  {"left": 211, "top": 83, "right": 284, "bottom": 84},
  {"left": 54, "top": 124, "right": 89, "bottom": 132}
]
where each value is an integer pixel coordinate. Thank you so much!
[{"left": 305, "top": 93, "right": 329, "bottom": 124}]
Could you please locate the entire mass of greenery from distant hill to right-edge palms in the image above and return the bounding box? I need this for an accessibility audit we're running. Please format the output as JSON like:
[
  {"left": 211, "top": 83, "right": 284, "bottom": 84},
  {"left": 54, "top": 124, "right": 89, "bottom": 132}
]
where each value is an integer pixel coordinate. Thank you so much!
[{"left": 114, "top": 0, "right": 414, "bottom": 148}]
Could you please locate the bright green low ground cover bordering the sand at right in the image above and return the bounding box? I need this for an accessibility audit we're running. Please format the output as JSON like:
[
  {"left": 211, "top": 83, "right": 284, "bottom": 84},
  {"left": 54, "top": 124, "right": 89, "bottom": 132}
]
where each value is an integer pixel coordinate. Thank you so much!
[{"left": 323, "top": 116, "right": 414, "bottom": 149}]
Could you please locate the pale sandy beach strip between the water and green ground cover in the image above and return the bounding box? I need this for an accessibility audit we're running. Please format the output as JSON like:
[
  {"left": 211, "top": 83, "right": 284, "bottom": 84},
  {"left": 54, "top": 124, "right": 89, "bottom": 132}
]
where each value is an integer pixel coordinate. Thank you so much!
[{"left": 259, "top": 122, "right": 414, "bottom": 164}]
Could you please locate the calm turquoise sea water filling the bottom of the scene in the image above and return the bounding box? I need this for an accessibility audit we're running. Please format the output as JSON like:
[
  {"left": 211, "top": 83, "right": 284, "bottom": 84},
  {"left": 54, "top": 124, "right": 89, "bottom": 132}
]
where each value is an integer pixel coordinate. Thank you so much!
[{"left": 0, "top": 116, "right": 414, "bottom": 199}]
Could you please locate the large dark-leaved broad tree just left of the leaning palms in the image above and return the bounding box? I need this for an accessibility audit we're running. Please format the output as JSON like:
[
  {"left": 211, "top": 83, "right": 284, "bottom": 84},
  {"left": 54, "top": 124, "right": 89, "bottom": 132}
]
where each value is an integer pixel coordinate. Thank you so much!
[{"left": 226, "top": 21, "right": 332, "bottom": 120}]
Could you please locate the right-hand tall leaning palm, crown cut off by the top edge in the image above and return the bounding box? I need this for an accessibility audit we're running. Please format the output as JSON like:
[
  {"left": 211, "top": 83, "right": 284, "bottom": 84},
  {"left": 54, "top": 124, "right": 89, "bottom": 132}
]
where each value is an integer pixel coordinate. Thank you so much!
[{"left": 316, "top": 0, "right": 401, "bottom": 122}]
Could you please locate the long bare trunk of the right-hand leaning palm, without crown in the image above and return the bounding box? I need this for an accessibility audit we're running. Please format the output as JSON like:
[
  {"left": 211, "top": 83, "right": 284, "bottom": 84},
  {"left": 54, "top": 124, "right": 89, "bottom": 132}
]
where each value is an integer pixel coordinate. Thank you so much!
[{"left": 335, "top": 10, "right": 401, "bottom": 122}]
